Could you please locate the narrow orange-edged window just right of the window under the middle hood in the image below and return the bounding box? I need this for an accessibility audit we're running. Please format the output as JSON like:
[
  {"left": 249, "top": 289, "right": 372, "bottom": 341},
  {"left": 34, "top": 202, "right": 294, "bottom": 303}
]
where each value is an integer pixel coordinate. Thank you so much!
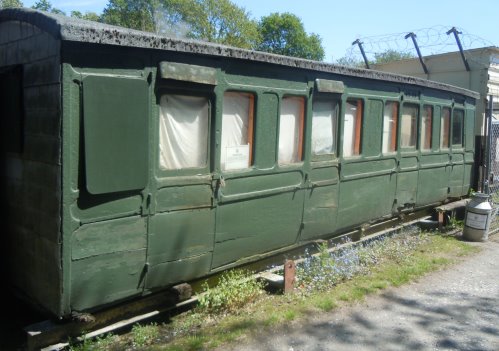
[{"left": 343, "top": 99, "right": 362, "bottom": 157}]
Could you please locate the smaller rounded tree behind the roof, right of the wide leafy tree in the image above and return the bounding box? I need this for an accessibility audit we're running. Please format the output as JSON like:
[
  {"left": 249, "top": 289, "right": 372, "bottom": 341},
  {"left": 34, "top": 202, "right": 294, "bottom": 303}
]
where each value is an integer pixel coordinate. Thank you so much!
[{"left": 258, "top": 13, "right": 324, "bottom": 61}]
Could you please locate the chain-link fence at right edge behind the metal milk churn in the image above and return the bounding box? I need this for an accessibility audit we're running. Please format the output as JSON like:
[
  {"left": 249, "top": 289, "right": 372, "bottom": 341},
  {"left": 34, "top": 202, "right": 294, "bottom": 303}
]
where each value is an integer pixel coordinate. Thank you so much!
[{"left": 483, "top": 94, "right": 499, "bottom": 233}]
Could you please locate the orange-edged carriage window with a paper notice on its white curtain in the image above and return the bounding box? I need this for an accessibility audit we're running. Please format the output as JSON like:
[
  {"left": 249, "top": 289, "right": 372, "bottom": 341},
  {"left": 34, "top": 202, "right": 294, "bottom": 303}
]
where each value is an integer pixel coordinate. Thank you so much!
[{"left": 220, "top": 92, "right": 255, "bottom": 170}]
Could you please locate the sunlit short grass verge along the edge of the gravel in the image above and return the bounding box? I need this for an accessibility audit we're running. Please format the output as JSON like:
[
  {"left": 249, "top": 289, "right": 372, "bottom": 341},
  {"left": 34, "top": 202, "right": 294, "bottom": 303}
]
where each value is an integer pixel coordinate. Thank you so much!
[{"left": 69, "top": 231, "right": 479, "bottom": 351}]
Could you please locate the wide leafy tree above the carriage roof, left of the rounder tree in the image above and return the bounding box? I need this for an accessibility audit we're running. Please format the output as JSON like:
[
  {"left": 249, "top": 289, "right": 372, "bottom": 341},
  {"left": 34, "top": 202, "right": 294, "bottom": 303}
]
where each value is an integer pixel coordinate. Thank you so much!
[{"left": 101, "top": 0, "right": 258, "bottom": 49}]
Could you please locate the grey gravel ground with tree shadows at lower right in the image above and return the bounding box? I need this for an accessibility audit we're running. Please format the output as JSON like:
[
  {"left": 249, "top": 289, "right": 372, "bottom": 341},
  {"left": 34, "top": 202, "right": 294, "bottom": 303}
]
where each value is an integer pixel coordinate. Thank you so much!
[{"left": 219, "top": 234, "right": 499, "bottom": 351}]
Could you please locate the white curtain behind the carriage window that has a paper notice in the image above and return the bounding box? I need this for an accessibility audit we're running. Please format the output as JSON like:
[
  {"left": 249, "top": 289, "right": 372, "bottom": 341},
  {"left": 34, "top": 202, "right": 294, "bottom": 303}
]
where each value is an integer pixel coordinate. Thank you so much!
[{"left": 220, "top": 93, "right": 252, "bottom": 170}]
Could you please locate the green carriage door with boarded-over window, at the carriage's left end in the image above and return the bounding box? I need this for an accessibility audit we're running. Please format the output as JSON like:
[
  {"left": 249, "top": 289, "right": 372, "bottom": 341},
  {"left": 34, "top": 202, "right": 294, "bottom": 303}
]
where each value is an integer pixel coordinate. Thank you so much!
[{"left": 70, "top": 75, "right": 149, "bottom": 311}]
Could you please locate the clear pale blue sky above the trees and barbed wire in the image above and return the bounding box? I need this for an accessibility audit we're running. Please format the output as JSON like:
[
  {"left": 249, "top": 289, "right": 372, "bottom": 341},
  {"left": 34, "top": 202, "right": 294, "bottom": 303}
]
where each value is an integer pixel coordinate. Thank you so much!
[{"left": 23, "top": 0, "right": 499, "bottom": 62}]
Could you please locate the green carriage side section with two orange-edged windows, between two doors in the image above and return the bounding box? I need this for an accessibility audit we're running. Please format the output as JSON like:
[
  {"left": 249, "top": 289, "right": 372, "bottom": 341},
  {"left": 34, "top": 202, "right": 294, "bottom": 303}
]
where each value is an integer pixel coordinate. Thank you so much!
[{"left": 212, "top": 92, "right": 305, "bottom": 269}]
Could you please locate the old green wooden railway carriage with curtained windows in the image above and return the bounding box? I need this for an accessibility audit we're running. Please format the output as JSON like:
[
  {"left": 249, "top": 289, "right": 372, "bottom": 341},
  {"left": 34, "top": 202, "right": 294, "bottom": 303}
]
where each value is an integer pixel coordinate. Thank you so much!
[{"left": 0, "top": 9, "right": 478, "bottom": 317}]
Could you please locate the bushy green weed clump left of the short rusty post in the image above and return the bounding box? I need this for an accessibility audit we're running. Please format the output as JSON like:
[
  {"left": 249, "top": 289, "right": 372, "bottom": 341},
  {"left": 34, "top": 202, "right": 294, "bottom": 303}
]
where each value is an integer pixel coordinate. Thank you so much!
[{"left": 199, "top": 270, "right": 263, "bottom": 313}]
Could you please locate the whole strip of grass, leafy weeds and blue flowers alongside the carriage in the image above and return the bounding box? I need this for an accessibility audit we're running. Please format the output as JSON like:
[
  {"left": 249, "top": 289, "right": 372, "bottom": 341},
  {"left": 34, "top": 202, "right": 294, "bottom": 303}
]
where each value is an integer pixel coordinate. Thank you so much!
[{"left": 67, "top": 228, "right": 478, "bottom": 351}]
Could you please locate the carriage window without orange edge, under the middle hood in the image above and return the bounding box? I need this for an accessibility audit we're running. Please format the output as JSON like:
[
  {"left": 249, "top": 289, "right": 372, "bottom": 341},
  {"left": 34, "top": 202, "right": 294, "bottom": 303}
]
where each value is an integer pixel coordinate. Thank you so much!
[{"left": 312, "top": 100, "right": 338, "bottom": 155}]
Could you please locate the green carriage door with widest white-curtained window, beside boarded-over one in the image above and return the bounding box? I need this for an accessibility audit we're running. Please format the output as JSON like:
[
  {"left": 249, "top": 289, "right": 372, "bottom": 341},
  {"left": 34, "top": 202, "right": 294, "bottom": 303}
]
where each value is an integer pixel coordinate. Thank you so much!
[{"left": 146, "top": 93, "right": 215, "bottom": 290}]
